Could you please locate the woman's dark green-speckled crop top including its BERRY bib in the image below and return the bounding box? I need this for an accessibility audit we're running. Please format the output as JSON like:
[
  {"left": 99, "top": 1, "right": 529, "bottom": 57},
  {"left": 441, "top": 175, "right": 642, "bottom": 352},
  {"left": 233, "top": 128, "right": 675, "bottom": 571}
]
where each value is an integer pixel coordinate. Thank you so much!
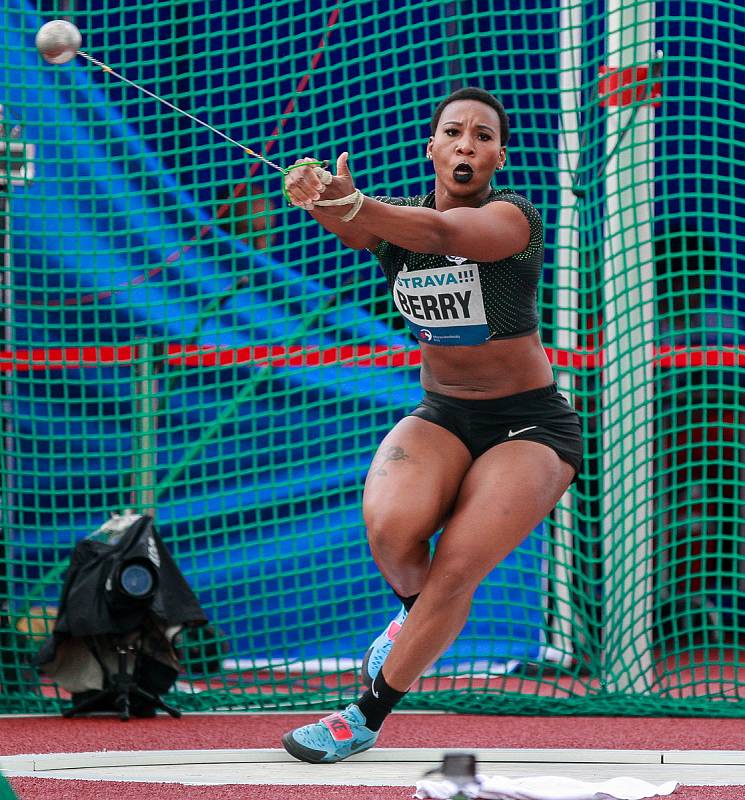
[{"left": 373, "top": 189, "right": 543, "bottom": 345}]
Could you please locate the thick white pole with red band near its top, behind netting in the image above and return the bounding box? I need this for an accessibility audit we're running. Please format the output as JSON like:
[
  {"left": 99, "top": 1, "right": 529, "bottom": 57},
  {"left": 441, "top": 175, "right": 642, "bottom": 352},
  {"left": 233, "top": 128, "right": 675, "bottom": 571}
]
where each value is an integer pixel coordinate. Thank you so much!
[{"left": 602, "top": 0, "right": 655, "bottom": 694}]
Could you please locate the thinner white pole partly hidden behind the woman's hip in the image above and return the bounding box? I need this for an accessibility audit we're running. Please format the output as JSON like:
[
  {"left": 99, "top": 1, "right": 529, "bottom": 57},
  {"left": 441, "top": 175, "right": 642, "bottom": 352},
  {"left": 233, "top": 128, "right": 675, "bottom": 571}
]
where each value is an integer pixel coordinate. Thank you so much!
[{"left": 551, "top": 0, "right": 583, "bottom": 666}]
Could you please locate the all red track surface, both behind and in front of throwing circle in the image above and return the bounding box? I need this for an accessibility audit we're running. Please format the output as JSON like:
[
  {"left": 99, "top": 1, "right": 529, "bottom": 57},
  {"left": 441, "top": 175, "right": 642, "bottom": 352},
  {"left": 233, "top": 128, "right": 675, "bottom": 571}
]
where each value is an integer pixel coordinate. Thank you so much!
[{"left": 0, "top": 713, "right": 745, "bottom": 800}]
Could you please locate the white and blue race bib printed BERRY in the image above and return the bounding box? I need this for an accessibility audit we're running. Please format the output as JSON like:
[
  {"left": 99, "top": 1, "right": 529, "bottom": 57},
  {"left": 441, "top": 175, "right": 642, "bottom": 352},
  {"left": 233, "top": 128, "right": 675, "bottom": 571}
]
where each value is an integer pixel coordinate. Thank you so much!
[{"left": 393, "top": 257, "right": 489, "bottom": 345}]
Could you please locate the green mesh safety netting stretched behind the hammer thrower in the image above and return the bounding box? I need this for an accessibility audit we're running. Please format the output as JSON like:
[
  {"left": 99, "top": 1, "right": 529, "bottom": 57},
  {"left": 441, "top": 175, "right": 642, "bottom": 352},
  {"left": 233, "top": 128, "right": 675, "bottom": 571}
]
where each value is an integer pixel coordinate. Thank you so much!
[{"left": 0, "top": 0, "right": 745, "bottom": 715}]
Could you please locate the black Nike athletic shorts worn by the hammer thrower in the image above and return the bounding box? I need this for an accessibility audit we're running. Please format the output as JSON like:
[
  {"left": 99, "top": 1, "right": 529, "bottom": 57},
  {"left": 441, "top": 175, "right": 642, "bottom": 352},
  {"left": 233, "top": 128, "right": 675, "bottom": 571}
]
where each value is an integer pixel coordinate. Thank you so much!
[{"left": 409, "top": 383, "right": 582, "bottom": 481}]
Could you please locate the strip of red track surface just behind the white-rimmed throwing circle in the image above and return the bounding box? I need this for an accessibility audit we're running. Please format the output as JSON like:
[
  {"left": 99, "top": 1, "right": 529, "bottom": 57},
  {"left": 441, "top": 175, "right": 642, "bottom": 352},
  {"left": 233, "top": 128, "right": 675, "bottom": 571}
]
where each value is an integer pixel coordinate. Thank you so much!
[{"left": 7, "top": 713, "right": 745, "bottom": 756}]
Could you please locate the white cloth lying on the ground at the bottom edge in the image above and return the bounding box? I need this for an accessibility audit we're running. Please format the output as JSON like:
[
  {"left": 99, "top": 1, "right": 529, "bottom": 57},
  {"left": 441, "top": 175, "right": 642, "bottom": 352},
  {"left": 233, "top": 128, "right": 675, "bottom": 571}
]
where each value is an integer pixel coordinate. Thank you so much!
[{"left": 414, "top": 775, "right": 678, "bottom": 800}]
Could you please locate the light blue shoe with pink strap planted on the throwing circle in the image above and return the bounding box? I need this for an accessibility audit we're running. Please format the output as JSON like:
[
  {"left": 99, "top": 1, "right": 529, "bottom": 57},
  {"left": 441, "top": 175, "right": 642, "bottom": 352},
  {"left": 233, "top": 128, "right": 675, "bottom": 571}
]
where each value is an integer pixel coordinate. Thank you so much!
[{"left": 282, "top": 704, "right": 380, "bottom": 764}]
